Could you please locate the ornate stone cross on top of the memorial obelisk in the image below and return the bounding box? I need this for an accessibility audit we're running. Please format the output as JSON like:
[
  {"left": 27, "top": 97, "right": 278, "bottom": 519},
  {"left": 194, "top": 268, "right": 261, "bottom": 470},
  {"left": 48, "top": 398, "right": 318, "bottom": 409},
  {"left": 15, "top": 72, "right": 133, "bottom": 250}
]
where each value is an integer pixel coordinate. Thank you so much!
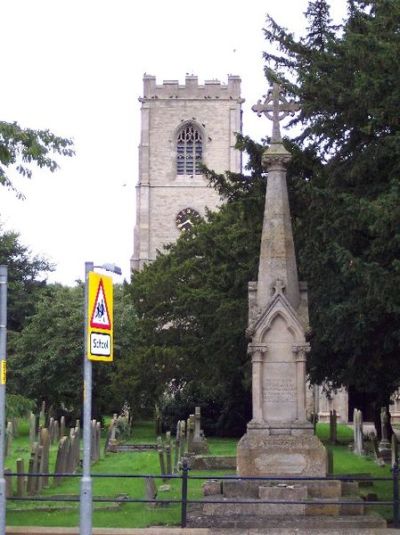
[{"left": 251, "top": 83, "right": 300, "bottom": 143}]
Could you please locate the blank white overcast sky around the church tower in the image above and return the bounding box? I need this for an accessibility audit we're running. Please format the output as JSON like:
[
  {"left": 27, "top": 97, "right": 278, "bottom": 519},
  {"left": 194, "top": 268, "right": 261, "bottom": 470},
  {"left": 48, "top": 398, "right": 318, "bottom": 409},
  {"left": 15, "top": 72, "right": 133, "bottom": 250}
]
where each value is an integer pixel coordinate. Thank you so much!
[{"left": 0, "top": 0, "right": 345, "bottom": 285}]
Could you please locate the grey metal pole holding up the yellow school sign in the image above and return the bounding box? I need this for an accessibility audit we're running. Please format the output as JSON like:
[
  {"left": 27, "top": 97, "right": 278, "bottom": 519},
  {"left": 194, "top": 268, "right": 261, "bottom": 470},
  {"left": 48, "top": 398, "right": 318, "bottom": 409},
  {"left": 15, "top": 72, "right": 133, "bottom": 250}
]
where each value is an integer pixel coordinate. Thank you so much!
[{"left": 79, "top": 262, "right": 94, "bottom": 535}]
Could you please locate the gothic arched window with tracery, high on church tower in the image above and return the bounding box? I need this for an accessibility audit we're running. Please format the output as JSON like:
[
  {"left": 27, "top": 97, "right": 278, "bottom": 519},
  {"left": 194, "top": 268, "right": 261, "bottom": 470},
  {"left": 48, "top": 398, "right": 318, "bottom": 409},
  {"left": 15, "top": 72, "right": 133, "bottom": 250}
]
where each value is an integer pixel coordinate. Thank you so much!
[{"left": 176, "top": 123, "right": 203, "bottom": 175}]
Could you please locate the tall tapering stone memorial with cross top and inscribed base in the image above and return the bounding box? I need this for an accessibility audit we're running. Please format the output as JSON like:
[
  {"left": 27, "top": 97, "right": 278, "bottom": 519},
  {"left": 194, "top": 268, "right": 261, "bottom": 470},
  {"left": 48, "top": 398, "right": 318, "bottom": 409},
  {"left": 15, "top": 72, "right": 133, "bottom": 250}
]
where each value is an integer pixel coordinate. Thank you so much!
[{"left": 237, "top": 84, "right": 326, "bottom": 476}]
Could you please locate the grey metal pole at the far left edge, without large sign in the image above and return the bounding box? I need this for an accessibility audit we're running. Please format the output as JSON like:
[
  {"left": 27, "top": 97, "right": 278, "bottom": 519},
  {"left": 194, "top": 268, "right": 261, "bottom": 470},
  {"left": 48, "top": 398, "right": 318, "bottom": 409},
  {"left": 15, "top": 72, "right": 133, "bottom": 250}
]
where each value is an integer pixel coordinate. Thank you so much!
[{"left": 0, "top": 266, "right": 7, "bottom": 535}]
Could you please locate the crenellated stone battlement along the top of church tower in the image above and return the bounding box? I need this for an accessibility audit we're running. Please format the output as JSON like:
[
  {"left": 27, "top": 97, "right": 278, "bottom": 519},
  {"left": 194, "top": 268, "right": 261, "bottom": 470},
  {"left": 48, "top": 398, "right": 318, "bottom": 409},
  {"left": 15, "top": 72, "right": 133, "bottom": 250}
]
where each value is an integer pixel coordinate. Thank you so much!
[{"left": 139, "top": 74, "right": 243, "bottom": 102}]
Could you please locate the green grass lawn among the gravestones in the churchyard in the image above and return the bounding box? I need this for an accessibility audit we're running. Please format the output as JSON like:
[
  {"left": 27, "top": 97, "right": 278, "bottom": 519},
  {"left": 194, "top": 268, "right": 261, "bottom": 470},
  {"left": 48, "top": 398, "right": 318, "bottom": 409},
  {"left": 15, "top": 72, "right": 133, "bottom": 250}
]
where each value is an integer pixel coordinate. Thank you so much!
[{"left": 6, "top": 422, "right": 392, "bottom": 528}]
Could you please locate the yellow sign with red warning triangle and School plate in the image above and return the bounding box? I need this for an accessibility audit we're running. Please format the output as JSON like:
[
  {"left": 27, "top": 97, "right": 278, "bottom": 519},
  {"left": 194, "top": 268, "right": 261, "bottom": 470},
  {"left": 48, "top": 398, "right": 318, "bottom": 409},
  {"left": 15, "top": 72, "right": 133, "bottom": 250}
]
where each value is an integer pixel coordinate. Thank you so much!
[{"left": 86, "top": 271, "right": 113, "bottom": 362}]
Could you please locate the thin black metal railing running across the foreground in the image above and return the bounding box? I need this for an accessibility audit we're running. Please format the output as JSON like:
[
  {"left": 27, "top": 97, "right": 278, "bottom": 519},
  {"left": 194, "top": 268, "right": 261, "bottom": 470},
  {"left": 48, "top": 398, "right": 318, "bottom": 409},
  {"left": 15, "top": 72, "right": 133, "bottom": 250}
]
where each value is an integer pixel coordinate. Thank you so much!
[{"left": 7, "top": 460, "right": 400, "bottom": 529}]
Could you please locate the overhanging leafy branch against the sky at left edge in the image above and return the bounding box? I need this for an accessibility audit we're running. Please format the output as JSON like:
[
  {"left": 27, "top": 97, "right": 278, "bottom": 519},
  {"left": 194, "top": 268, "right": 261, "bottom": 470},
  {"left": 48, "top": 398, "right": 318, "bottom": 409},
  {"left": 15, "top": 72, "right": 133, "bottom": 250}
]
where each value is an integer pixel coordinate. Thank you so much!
[{"left": 0, "top": 121, "right": 74, "bottom": 198}]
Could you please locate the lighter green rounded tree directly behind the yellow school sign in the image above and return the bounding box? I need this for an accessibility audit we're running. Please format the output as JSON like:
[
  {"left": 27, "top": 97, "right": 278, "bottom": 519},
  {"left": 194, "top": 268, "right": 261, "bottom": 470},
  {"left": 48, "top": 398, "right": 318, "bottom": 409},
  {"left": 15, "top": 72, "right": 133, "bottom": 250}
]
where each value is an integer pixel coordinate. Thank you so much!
[{"left": 8, "top": 283, "right": 132, "bottom": 419}]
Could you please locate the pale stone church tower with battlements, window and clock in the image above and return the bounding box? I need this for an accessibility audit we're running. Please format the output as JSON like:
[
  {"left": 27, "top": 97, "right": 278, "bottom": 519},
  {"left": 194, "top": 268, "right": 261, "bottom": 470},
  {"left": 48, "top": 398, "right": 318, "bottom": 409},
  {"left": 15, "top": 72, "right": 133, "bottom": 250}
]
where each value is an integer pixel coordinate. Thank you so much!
[{"left": 131, "top": 75, "right": 243, "bottom": 270}]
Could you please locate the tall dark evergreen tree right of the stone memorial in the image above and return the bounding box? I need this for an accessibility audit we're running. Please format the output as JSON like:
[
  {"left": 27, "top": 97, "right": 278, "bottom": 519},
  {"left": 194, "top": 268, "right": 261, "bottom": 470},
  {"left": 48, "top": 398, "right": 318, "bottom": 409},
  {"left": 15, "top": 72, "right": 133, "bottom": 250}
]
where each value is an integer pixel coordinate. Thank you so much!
[{"left": 265, "top": 0, "right": 400, "bottom": 426}]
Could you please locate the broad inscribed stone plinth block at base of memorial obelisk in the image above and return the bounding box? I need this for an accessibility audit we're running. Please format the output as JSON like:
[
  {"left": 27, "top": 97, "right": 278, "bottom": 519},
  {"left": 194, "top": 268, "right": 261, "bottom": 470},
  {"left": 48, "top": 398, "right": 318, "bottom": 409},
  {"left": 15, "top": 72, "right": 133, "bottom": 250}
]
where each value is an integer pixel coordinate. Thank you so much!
[{"left": 237, "top": 429, "right": 327, "bottom": 477}]
